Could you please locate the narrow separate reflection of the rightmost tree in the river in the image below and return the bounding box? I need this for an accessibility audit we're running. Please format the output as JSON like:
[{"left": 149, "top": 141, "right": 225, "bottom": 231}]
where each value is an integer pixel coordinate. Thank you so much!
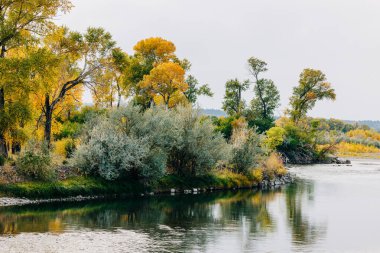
[{"left": 285, "top": 182, "right": 326, "bottom": 246}]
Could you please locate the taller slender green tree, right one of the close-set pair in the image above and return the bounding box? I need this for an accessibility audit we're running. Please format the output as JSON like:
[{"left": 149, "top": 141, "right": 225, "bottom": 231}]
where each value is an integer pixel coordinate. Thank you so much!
[{"left": 248, "top": 57, "right": 280, "bottom": 132}]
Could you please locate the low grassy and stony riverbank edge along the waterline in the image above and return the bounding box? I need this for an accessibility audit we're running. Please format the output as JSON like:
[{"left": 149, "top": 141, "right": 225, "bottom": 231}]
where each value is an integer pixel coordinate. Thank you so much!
[{"left": 0, "top": 172, "right": 295, "bottom": 207}]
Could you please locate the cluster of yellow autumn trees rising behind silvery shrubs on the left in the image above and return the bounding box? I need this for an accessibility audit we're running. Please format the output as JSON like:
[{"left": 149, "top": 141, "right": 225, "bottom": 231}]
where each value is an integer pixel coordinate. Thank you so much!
[{"left": 0, "top": 0, "right": 212, "bottom": 157}]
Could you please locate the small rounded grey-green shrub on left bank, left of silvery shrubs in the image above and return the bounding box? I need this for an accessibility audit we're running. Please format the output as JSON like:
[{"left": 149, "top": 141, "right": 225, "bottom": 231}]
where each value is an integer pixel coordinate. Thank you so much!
[{"left": 16, "top": 141, "right": 56, "bottom": 181}]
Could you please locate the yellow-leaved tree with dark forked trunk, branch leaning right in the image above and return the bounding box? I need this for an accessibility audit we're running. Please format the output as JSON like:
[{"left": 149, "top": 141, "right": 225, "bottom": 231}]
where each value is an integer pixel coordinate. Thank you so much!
[{"left": 35, "top": 27, "right": 115, "bottom": 145}]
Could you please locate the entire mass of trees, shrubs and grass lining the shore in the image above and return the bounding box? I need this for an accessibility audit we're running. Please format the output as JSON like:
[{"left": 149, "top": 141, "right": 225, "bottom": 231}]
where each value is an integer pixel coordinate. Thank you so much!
[{"left": 0, "top": 0, "right": 380, "bottom": 203}]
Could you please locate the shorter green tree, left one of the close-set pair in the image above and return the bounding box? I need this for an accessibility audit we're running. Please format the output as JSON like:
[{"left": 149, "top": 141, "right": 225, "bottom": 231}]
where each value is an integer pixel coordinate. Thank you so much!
[{"left": 223, "top": 79, "right": 249, "bottom": 115}]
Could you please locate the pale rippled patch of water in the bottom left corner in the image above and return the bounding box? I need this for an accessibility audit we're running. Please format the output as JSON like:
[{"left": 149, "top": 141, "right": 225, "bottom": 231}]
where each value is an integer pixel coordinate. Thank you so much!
[{"left": 0, "top": 230, "right": 159, "bottom": 253}]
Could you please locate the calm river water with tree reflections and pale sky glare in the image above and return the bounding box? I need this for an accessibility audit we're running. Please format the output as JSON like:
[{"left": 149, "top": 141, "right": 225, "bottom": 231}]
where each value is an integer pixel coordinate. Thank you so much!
[{"left": 0, "top": 160, "right": 380, "bottom": 253}]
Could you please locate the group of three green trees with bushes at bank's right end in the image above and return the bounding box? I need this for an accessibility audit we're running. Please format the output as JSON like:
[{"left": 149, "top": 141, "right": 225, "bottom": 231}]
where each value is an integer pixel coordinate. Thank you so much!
[{"left": 221, "top": 57, "right": 339, "bottom": 163}]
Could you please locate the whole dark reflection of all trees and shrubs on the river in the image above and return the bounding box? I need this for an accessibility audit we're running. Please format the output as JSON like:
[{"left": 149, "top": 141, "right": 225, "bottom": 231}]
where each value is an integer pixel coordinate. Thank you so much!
[{"left": 0, "top": 184, "right": 325, "bottom": 252}]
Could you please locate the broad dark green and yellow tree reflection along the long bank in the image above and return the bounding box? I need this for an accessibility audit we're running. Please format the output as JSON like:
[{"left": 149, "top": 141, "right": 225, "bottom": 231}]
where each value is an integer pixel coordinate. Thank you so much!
[{"left": 0, "top": 190, "right": 279, "bottom": 251}]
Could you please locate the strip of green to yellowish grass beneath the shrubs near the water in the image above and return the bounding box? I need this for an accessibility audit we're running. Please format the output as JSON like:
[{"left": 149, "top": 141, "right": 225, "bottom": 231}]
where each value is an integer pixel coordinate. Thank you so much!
[{"left": 0, "top": 170, "right": 257, "bottom": 199}]
